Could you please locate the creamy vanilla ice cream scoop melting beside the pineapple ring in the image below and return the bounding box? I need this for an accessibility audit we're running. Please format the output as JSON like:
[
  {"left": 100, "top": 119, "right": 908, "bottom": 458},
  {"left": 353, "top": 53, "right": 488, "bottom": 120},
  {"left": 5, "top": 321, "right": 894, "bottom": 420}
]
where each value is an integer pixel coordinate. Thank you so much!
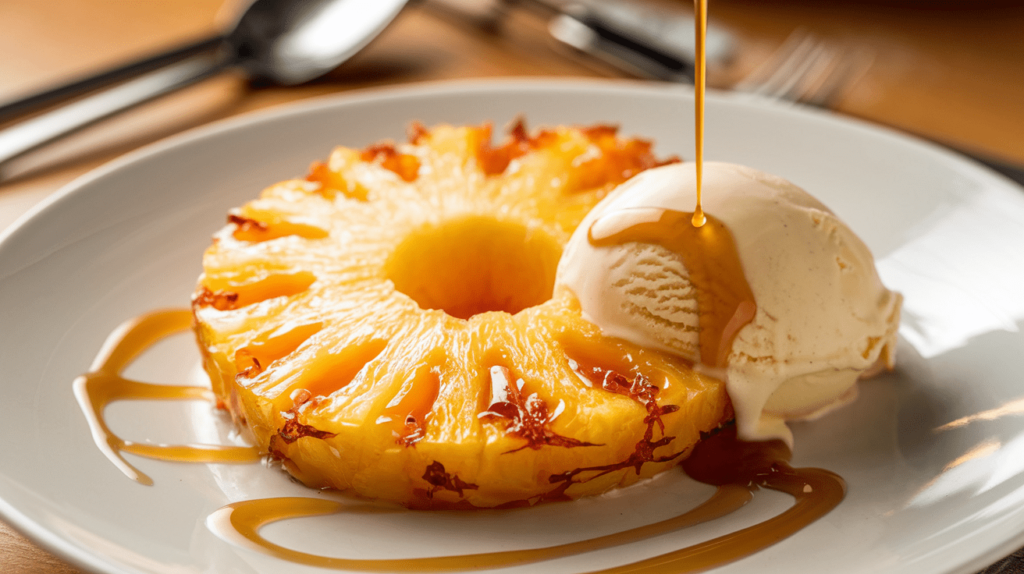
[{"left": 555, "top": 162, "right": 901, "bottom": 446}]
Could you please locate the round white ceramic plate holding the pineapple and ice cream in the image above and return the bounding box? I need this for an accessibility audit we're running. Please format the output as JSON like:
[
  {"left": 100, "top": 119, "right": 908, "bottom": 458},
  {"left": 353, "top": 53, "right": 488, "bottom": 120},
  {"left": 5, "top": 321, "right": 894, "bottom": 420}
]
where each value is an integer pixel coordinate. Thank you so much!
[{"left": 0, "top": 82, "right": 1024, "bottom": 574}]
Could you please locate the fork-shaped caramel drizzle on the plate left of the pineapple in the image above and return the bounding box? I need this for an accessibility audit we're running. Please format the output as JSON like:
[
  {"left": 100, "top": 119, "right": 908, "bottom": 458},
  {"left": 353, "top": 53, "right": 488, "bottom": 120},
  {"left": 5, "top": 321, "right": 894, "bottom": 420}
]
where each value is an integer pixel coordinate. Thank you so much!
[{"left": 74, "top": 310, "right": 259, "bottom": 485}]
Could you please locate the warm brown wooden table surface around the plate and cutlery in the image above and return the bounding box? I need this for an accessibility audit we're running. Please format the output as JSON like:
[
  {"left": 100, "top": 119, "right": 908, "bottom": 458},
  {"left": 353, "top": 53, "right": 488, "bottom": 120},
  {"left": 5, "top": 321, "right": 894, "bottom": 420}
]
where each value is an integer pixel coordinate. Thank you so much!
[{"left": 0, "top": 0, "right": 1024, "bottom": 574}]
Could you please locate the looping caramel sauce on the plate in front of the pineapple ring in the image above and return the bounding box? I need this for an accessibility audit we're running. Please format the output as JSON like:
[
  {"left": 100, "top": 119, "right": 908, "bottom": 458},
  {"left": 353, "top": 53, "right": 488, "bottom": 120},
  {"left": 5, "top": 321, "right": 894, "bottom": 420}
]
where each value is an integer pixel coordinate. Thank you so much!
[{"left": 207, "top": 428, "right": 846, "bottom": 574}]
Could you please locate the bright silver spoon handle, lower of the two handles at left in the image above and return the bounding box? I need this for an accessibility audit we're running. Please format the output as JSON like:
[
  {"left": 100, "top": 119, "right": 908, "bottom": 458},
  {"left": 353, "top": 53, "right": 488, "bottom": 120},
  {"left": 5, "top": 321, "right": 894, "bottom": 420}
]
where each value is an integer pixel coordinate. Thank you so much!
[{"left": 0, "top": 52, "right": 233, "bottom": 174}]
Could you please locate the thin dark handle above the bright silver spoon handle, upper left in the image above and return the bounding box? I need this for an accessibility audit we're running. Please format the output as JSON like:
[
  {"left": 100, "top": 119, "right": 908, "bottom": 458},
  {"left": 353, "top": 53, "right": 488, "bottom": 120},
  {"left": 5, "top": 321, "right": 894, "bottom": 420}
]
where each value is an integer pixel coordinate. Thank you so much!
[{"left": 0, "top": 36, "right": 224, "bottom": 122}]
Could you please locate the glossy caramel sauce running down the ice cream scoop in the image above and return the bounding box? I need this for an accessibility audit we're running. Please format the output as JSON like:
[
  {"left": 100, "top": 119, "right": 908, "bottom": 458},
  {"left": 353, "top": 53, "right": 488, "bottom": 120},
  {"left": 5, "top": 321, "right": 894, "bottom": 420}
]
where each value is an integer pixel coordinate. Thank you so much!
[{"left": 589, "top": 208, "right": 757, "bottom": 367}]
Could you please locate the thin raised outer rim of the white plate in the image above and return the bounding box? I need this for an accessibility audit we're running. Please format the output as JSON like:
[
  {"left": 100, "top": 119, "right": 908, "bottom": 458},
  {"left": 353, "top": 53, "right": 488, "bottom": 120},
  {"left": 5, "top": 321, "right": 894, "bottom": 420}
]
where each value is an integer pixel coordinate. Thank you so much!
[{"left": 0, "top": 77, "right": 1024, "bottom": 574}]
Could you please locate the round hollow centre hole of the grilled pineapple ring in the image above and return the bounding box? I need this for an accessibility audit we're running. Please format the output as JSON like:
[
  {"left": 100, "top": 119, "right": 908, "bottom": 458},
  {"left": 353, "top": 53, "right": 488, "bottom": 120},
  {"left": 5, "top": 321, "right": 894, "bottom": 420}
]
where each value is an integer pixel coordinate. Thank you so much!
[{"left": 385, "top": 217, "right": 562, "bottom": 319}]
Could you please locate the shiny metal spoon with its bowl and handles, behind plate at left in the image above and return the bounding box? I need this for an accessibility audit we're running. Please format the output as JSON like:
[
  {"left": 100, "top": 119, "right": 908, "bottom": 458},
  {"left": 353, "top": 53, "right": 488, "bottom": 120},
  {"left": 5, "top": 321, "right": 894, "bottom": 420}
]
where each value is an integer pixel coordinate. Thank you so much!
[{"left": 0, "top": 0, "right": 407, "bottom": 178}]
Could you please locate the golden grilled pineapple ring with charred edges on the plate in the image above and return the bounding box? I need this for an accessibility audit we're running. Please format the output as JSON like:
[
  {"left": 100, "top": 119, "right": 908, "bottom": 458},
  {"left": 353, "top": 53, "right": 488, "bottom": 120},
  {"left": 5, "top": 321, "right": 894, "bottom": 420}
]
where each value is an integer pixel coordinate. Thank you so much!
[{"left": 193, "top": 120, "right": 731, "bottom": 507}]
